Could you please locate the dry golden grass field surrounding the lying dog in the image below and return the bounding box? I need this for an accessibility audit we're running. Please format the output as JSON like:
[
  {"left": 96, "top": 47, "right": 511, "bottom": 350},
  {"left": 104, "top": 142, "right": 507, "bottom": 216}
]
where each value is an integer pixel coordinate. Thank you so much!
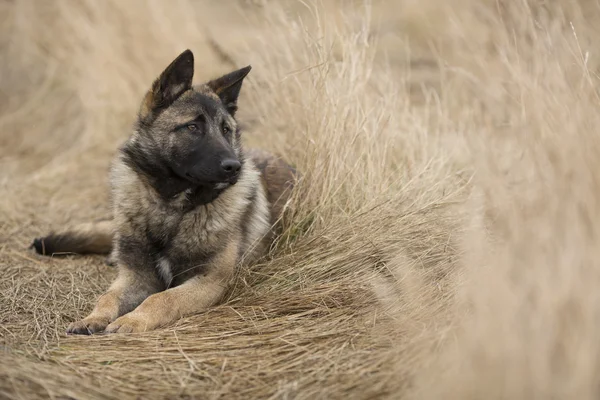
[{"left": 0, "top": 0, "right": 600, "bottom": 400}]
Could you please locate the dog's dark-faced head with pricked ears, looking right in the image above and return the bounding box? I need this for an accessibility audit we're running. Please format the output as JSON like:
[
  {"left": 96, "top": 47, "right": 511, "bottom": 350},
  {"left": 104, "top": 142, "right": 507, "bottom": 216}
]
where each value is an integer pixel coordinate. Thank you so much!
[{"left": 124, "top": 50, "right": 250, "bottom": 199}]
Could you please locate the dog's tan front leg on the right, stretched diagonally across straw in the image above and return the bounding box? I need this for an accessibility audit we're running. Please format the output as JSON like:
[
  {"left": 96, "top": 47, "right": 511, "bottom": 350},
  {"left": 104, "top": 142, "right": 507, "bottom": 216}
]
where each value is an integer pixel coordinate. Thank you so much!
[{"left": 106, "top": 241, "right": 238, "bottom": 333}]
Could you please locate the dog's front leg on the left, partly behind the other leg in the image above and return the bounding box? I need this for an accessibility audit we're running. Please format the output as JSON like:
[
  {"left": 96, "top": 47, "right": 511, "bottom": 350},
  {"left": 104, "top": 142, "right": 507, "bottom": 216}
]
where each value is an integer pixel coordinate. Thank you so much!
[{"left": 67, "top": 265, "right": 162, "bottom": 335}]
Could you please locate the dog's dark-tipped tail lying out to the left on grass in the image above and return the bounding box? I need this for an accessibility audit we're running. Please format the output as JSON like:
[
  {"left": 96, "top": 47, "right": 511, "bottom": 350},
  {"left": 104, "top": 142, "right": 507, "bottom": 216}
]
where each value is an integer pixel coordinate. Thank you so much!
[{"left": 31, "top": 220, "right": 113, "bottom": 256}]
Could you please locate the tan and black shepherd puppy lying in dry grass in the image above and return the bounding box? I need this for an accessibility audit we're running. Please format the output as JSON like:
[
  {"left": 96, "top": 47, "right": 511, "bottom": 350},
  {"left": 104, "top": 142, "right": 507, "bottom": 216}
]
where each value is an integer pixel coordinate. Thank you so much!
[{"left": 32, "top": 50, "right": 295, "bottom": 334}]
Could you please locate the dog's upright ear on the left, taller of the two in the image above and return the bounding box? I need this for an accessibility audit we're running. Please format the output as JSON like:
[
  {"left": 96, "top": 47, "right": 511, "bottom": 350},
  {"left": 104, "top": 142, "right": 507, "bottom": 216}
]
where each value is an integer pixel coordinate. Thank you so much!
[{"left": 140, "top": 50, "right": 194, "bottom": 119}]
